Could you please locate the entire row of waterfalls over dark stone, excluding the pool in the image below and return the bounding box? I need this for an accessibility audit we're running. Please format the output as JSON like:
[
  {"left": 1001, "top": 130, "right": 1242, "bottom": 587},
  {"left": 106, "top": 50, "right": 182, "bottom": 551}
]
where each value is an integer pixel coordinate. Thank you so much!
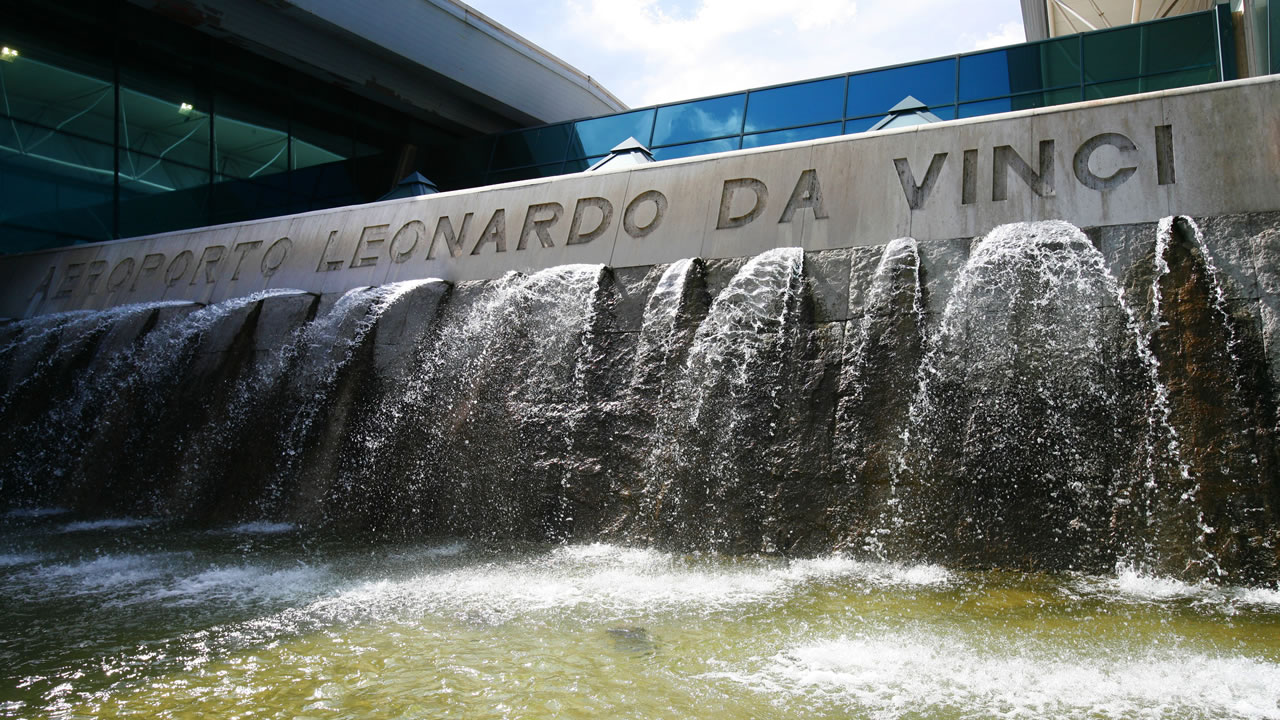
[{"left": 0, "top": 218, "right": 1280, "bottom": 583}]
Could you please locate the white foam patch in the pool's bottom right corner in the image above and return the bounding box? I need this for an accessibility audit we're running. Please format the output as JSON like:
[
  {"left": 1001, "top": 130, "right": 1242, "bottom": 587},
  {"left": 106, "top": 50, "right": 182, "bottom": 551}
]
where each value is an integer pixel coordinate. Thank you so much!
[{"left": 716, "top": 633, "right": 1280, "bottom": 720}]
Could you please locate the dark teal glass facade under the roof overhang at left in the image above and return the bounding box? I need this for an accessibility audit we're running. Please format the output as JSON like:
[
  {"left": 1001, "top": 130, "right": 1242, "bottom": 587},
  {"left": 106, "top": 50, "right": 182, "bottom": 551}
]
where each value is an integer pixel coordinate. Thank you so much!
[{"left": 0, "top": 0, "right": 450, "bottom": 252}]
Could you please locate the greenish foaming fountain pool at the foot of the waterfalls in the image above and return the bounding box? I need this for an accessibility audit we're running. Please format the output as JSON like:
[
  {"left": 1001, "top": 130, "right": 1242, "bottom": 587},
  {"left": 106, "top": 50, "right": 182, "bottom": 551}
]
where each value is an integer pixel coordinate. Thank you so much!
[{"left": 0, "top": 507, "right": 1280, "bottom": 719}]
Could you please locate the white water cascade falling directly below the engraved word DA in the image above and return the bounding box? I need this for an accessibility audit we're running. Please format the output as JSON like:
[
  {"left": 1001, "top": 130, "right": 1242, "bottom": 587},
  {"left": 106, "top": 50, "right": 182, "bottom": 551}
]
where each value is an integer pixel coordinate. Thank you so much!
[{"left": 644, "top": 249, "right": 805, "bottom": 551}]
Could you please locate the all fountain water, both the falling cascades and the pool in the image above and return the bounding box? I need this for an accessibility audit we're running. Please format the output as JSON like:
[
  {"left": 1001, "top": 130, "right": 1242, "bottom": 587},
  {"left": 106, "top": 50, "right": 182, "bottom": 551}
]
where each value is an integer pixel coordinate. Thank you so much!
[{"left": 0, "top": 219, "right": 1280, "bottom": 720}]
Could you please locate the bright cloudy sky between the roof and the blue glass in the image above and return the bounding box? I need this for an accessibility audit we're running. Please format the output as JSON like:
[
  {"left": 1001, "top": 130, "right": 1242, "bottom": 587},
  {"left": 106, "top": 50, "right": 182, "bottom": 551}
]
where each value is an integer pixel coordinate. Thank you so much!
[{"left": 463, "top": 0, "right": 1024, "bottom": 108}]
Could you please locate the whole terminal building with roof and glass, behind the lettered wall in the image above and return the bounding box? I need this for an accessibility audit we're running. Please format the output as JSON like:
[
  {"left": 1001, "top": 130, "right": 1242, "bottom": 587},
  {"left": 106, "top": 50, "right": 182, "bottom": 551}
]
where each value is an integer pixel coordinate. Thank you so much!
[{"left": 0, "top": 0, "right": 1280, "bottom": 252}]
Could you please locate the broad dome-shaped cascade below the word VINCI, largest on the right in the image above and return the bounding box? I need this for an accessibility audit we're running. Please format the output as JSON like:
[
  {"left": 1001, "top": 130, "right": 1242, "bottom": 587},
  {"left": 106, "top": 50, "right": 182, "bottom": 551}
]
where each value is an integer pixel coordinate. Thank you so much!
[{"left": 882, "top": 223, "right": 1172, "bottom": 569}]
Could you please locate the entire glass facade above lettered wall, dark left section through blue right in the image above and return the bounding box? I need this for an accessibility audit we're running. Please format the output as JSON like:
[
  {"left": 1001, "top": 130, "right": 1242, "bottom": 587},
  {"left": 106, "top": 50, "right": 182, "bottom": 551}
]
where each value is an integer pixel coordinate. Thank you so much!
[{"left": 0, "top": 0, "right": 1239, "bottom": 252}]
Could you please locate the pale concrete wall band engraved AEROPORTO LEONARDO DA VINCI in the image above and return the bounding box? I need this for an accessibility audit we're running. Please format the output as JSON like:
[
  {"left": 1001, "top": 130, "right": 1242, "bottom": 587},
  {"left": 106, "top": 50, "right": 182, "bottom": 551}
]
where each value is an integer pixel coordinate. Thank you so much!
[{"left": 0, "top": 77, "right": 1280, "bottom": 318}]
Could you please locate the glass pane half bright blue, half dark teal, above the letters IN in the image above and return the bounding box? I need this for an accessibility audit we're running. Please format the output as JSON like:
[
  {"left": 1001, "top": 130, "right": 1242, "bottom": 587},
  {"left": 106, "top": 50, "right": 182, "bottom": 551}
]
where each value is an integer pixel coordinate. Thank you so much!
[{"left": 960, "top": 37, "right": 1080, "bottom": 100}]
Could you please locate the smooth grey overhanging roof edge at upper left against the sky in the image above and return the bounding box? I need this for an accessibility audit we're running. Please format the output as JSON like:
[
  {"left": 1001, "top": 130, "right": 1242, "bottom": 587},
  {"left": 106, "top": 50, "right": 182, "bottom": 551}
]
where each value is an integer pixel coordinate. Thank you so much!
[{"left": 129, "top": 0, "right": 626, "bottom": 132}]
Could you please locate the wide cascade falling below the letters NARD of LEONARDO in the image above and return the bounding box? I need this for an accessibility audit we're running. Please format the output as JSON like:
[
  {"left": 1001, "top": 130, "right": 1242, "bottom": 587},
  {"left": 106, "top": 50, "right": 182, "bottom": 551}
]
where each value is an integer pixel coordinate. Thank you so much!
[{"left": 332, "top": 265, "right": 604, "bottom": 538}]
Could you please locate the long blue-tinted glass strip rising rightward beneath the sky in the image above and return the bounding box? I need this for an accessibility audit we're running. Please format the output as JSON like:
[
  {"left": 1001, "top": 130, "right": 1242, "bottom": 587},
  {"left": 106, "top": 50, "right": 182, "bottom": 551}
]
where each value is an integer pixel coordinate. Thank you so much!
[{"left": 439, "top": 10, "right": 1234, "bottom": 190}]
